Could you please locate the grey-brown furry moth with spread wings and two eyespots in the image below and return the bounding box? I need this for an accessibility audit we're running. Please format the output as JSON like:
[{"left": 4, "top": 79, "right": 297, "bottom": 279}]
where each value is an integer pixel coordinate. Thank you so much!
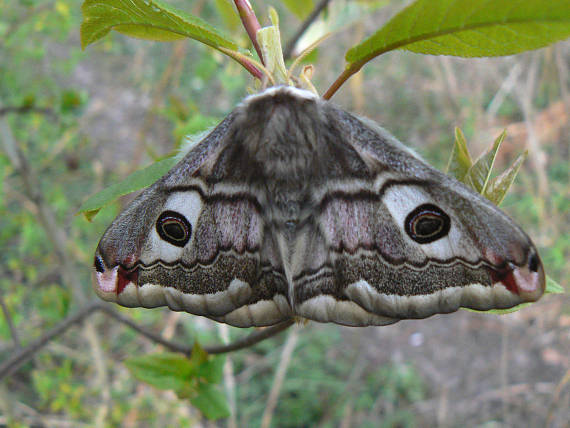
[{"left": 93, "top": 86, "right": 545, "bottom": 327}]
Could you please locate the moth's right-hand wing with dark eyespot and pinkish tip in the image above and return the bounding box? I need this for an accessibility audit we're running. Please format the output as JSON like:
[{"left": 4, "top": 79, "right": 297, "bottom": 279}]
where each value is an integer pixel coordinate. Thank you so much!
[{"left": 293, "top": 108, "right": 545, "bottom": 326}]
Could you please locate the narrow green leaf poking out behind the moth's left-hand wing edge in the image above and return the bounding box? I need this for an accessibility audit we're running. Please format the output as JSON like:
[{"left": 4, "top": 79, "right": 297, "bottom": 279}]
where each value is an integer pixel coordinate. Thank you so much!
[{"left": 78, "top": 157, "right": 178, "bottom": 221}]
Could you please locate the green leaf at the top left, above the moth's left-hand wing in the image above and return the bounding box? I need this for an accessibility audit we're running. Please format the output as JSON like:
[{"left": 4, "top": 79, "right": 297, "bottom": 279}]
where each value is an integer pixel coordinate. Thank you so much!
[{"left": 81, "top": 0, "right": 237, "bottom": 50}]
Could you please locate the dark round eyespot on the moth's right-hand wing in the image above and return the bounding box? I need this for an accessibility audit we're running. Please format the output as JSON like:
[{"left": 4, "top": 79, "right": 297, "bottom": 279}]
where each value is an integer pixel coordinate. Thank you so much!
[{"left": 404, "top": 204, "right": 451, "bottom": 244}]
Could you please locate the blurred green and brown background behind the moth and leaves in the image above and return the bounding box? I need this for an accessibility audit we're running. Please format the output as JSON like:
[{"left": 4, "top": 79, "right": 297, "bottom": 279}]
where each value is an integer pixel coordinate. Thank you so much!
[{"left": 0, "top": 0, "right": 570, "bottom": 427}]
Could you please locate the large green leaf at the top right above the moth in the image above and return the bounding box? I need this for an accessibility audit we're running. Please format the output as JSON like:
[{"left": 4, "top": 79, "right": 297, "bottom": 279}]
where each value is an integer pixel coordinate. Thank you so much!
[{"left": 346, "top": 0, "right": 570, "bottom": 66}]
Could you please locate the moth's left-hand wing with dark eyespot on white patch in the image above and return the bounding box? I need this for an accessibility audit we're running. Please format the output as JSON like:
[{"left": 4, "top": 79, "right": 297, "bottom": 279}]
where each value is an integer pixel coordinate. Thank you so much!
[{"left": 94, "top": 115, "right": 291, "bottom": 327}]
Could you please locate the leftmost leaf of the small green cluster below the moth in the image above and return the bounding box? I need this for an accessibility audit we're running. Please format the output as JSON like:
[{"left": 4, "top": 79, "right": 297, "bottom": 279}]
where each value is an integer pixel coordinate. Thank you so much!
[{"left": 125, "top": 352, "right": 195, "bottom": 391}]
